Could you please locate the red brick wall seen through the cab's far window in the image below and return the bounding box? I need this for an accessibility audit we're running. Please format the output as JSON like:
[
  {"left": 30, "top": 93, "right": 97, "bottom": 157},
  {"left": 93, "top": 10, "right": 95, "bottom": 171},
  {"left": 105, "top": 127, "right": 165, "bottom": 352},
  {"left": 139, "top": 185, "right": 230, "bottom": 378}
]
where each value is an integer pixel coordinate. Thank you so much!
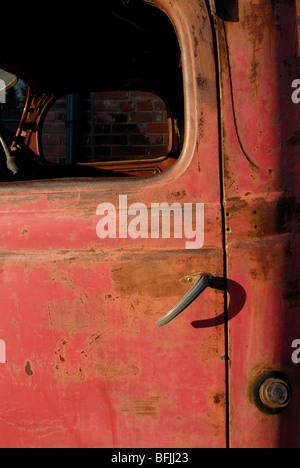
[{"left": 42, "top": 91, "right": 169, "bottom": 162}]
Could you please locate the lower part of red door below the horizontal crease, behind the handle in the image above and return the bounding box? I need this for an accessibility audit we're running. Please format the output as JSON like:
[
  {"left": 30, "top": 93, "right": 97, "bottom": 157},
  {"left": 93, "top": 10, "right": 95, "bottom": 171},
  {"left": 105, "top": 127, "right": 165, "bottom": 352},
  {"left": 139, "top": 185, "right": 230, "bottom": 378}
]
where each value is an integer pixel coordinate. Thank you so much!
[{"left": 1, "top": 250, "right": 225, "bottom": 447}]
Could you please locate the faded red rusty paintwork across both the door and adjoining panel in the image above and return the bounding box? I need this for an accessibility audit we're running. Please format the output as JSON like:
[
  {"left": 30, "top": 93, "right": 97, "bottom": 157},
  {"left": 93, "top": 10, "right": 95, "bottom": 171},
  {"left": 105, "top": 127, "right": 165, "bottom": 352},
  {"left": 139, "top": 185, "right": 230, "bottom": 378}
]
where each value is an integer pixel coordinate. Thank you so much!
[{"left": 0, "top": 0, "right": 300, "bottom": 448}]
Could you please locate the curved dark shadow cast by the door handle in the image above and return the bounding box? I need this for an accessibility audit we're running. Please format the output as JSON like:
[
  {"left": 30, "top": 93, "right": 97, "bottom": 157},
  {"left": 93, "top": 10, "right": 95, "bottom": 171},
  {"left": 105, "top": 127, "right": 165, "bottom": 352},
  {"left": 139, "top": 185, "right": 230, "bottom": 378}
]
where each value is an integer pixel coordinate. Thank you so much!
[{"left": 191, "top": 277, "right": 247, "bottom": 328}]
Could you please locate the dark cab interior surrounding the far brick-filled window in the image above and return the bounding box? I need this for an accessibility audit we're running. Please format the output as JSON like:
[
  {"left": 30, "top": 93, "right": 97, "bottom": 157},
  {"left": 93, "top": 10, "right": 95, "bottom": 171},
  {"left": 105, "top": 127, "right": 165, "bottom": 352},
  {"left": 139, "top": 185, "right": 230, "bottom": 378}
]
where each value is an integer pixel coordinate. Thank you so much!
[{"left": 0, "top": 0, "right": 184, "bottom": 182}]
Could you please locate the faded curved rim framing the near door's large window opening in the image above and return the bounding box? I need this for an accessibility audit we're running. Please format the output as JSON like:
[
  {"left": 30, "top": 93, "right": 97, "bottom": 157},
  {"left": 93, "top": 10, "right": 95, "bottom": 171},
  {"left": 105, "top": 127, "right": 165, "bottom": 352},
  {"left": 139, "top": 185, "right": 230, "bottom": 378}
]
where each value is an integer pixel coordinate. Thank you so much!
[{"left": 0, "top": 0, "right": 205, "bottom": 194}]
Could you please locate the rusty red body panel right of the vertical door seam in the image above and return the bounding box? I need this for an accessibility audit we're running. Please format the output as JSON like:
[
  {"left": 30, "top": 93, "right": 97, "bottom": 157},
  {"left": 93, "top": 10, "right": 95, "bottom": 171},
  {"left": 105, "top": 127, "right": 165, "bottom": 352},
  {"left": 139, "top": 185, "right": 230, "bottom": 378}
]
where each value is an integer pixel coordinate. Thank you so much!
[{"left": 217, "top": 0, "right": 300, "bottom": 448}]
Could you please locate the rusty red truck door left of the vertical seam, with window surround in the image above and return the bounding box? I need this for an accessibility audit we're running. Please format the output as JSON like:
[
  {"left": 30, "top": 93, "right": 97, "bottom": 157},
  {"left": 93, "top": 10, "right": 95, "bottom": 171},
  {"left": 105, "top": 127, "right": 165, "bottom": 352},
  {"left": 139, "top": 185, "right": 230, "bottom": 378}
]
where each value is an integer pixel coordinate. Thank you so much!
[{"left": 0, "top": 0, "right": 227, "bottom": 448}]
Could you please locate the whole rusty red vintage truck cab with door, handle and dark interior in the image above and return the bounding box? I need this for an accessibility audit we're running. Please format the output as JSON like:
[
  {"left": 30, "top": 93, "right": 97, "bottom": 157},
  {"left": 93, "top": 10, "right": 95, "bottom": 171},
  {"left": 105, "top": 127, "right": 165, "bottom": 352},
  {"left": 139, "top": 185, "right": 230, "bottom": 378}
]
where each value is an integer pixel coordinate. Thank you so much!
[{"left": 0, "top": 0, "right": 300, "bottom": 449}]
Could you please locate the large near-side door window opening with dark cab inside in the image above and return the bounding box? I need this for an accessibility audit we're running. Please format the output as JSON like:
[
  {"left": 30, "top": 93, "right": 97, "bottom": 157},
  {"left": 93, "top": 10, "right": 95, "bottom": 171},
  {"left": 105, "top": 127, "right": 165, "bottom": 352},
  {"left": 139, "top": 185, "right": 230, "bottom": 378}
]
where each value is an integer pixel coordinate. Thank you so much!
[{"left": 0, "top": 0, "right": 184, "bottom": 182}]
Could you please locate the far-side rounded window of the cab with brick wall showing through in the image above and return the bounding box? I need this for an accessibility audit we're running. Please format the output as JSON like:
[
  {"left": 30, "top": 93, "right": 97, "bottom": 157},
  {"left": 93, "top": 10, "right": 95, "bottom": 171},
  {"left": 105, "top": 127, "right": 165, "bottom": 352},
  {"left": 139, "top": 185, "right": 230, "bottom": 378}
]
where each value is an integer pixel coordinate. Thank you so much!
[{"left": 42, "top": 91, "right": 172, "bottom": 175}]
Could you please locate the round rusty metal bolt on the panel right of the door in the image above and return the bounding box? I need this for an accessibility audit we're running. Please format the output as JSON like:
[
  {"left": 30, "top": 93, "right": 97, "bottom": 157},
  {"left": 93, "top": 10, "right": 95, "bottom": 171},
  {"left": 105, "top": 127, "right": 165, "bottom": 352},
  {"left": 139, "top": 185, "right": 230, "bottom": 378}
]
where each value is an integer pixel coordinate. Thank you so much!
[{"left": 259, "top": 378, "right": 291, "bottom": 409}]
